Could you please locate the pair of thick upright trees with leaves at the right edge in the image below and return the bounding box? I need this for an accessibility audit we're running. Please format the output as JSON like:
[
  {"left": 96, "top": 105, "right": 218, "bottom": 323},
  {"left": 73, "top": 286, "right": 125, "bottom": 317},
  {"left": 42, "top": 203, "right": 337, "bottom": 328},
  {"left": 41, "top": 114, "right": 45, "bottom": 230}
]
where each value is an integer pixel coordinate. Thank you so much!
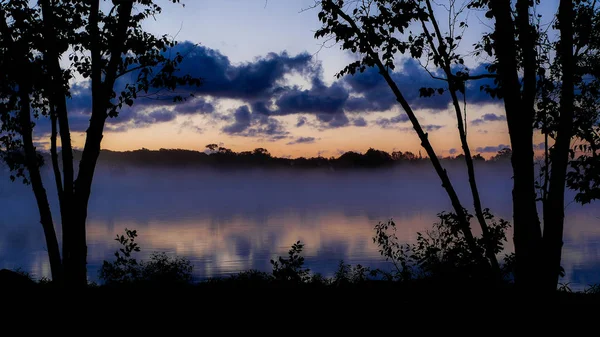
[{"left": 474, "top": 0, "right": 600, "bottom": 291}]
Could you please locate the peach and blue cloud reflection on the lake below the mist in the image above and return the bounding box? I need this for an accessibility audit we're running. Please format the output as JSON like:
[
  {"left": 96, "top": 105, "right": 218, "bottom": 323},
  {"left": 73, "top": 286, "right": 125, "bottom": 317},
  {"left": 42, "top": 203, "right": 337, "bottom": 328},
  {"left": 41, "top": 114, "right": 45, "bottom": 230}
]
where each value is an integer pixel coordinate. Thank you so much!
[{"left": 82, "top": 212, "right": 430, "bottom": 278}]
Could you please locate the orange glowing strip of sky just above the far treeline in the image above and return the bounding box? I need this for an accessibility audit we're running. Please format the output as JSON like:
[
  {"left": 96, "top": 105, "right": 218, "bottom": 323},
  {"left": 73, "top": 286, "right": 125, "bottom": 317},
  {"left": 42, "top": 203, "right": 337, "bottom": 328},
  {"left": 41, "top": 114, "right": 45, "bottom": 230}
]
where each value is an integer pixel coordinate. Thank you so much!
[{"left": 64, "top": 106, "right": 510, "bottom": 158}]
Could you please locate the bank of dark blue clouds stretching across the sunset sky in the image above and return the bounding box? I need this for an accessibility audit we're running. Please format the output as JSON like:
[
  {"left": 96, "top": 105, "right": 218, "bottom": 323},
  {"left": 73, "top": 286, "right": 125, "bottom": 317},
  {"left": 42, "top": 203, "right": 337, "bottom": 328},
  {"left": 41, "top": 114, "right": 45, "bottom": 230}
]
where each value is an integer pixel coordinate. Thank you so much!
[{"left": 41, "top": 42, "right": 504, "bottom": 137}]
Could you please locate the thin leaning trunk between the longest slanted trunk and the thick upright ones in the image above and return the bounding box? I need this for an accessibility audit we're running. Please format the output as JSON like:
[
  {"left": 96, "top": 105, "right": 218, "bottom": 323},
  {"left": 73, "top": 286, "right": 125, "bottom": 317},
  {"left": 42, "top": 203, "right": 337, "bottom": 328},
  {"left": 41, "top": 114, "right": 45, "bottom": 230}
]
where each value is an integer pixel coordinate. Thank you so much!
[{"left": 421, "top": 0, "right": 500, "bottom": 273}]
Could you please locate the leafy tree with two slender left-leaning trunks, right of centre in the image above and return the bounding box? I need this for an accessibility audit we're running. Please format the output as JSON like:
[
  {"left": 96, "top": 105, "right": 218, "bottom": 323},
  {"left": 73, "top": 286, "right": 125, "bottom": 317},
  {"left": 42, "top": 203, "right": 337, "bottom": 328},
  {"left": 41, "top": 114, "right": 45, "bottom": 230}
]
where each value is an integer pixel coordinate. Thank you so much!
[{"left": 315, "top": 0, "right": 499, "bottom": 274}]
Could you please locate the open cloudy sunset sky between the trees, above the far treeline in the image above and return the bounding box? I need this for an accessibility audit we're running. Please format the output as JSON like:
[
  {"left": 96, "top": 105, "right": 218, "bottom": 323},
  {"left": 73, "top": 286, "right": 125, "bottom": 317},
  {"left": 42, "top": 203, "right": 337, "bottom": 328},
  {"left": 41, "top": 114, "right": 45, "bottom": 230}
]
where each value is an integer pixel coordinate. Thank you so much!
[{"left": 41, "top": 0, "right": 564, "bottom": 157}]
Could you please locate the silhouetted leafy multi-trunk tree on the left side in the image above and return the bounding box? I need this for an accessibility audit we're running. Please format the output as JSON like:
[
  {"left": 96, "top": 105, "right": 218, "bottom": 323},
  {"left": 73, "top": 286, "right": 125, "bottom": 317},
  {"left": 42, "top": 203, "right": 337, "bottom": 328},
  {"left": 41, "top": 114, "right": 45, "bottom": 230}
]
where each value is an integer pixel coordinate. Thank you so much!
[{"left": 0, "top": 0, "right": 200, "bottom": 286}]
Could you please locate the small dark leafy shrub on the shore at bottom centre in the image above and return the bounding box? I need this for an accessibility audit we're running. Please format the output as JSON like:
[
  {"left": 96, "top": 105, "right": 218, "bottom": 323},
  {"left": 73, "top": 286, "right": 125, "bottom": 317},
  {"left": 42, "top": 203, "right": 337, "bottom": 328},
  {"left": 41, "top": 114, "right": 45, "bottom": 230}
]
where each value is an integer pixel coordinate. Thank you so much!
[{"left": 271, "top": 241, "right": 310, "bottom": 283}]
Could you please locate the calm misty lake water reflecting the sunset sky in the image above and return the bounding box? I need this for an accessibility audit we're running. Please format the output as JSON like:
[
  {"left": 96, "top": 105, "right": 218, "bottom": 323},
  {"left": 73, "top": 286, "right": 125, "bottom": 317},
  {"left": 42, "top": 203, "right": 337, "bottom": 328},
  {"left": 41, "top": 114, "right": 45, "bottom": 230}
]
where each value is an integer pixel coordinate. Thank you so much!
[{"left": 0, "top": 165, "right": 600, "bottom": 289}]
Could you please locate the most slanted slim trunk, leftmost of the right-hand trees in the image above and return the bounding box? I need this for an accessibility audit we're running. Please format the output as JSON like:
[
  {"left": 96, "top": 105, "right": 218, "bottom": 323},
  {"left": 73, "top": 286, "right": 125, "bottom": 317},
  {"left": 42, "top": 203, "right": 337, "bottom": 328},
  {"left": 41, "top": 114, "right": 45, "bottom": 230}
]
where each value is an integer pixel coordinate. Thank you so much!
[{"left": 335, "top": 7, "right": 477, "bottom": 251}]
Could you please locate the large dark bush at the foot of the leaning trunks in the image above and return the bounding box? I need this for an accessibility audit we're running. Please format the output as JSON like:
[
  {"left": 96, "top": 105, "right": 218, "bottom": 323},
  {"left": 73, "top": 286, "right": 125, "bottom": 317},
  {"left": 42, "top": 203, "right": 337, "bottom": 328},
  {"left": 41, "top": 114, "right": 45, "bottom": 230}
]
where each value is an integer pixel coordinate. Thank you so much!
[{"left": 373, "top": 209, "right": 512, "bottom": 281}]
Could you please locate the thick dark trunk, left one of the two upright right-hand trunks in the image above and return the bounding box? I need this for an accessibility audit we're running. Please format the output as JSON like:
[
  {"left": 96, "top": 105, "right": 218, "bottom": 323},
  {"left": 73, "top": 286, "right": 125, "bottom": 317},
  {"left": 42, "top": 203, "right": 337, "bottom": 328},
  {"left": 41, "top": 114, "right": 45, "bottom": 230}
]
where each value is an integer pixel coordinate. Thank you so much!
[{"left": 490, "top": 0, "right": 542, "bottom": 289}]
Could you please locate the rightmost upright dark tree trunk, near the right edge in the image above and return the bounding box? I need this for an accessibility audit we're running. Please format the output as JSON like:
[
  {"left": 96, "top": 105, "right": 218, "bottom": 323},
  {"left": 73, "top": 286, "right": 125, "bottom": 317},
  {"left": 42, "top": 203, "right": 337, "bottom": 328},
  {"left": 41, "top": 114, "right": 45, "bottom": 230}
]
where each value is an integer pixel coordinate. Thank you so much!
[{"left": 542, "top": 0, "right": 575, "bottom": 291}]
